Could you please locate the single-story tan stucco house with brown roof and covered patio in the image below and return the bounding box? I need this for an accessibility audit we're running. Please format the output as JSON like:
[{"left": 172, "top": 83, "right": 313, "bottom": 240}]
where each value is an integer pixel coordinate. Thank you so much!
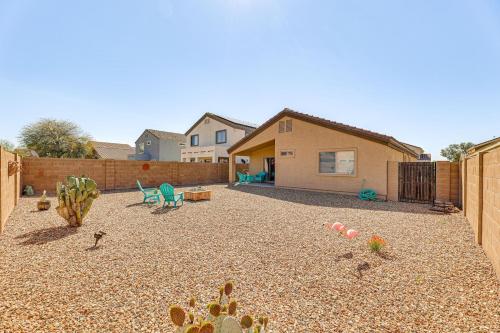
[{"left": 228, "top": 109, "right": 418, "bottom": 199}]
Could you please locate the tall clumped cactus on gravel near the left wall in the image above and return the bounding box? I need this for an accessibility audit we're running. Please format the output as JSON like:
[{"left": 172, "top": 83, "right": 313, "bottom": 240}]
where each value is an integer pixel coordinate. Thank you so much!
[{"left": 56, "top": 176, "right": 100, "bottom": 227}]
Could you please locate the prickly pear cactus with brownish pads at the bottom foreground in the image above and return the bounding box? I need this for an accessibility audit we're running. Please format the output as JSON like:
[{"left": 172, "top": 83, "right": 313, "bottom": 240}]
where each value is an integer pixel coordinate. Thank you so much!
[{"left": 169, "top": 282, "right": 269, "bottom": 333}]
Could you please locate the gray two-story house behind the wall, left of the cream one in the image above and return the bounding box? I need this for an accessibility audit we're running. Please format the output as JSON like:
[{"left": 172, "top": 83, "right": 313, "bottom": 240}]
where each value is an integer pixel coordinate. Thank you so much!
[{"left": 133, "top": 129, "right": 186, "bottom": 162}]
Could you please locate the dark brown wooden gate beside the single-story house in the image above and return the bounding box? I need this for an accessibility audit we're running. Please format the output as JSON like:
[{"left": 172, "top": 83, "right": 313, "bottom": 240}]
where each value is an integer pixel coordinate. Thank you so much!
[{"left": 398, "top": 162, "right": 436, "bottom": 203}]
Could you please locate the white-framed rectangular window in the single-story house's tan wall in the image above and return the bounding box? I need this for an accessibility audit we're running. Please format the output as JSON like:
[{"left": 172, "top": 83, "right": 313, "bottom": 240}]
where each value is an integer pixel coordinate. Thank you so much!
[{"left": 319, "top": 150, "right": 356, "bottom": 175}]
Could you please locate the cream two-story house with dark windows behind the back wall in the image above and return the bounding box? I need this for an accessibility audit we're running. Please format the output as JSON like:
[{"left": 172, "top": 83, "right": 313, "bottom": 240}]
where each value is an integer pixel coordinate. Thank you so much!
[{"left": 181, "top": 112, "right": 257, "bottom": 163}]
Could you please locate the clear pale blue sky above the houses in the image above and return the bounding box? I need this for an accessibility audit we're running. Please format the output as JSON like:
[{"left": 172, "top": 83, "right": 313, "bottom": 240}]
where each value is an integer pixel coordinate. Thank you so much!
[{"left": 0, "top": 0, "right": 500, "bottom": 159}]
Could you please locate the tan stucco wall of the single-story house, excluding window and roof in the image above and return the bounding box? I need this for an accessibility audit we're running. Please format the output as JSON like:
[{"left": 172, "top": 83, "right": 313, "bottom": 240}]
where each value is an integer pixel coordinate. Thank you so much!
[{"left": 233, "top": 117, "right": 414, "bottom": 198}]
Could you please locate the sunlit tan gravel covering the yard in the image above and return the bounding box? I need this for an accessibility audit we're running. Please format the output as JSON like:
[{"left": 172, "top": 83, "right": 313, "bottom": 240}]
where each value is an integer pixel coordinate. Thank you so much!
[{"left": 0, "top": 185, "right": 500, "bottom": 332}]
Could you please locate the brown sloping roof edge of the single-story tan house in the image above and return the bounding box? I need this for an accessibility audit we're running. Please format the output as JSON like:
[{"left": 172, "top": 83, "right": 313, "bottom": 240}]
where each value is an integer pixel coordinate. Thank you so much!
[{"left": 227, "top": 108, "right": 418, "bottom": 157}]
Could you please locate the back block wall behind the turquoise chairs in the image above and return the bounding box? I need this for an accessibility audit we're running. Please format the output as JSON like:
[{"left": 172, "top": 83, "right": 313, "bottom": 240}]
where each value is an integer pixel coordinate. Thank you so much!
[{"left": 22, "top": 158, "right": 229, "bottom": 193}]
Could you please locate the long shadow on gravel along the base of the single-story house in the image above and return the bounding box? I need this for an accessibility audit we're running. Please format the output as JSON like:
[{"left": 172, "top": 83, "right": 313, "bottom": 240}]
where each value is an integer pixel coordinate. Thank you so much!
[{"left": 227, "top": 186, "right": 436, "bottom": 215}]
